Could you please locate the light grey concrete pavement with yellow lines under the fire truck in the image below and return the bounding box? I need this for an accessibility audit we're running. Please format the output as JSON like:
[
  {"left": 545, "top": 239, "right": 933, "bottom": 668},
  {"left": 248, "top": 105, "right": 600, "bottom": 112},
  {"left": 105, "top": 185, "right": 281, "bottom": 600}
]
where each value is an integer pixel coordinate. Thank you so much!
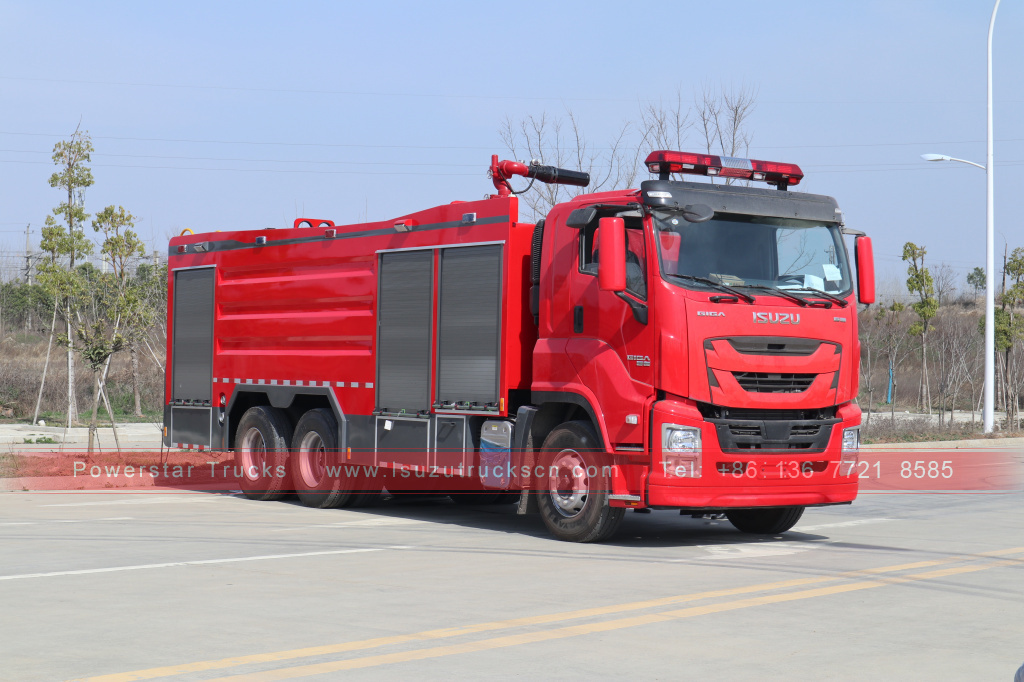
[{"left": 0, "top": 485, "right": 1024, "bottom": 681}]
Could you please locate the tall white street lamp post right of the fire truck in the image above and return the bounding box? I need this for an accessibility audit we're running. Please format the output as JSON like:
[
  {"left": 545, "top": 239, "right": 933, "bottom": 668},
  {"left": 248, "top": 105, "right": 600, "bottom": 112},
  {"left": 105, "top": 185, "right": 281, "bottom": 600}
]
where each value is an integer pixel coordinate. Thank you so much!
[{"left": 922, "top": 0, "right": 999, "bottom": 433}]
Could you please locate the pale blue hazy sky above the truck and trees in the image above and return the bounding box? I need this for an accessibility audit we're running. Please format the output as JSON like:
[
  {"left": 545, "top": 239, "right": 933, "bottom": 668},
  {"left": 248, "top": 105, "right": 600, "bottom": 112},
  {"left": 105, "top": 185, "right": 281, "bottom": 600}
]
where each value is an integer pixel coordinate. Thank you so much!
[{"left": 0, "top": 0, "right": 1024, "bottom": 288}]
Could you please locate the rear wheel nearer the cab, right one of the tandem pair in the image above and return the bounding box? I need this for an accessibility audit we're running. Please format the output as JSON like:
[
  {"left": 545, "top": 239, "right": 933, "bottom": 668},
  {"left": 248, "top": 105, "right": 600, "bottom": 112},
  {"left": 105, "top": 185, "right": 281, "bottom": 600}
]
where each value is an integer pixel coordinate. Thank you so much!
[{"left": 292, "top": 408, "right": 353, "bottom": 509}]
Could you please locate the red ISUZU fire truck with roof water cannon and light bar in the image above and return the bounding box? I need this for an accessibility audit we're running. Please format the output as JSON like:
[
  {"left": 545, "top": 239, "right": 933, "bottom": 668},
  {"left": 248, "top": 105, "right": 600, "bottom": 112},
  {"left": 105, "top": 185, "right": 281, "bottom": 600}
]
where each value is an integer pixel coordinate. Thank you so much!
[{"left": 164, "top": 151, "right": 874, "bottom": 542}]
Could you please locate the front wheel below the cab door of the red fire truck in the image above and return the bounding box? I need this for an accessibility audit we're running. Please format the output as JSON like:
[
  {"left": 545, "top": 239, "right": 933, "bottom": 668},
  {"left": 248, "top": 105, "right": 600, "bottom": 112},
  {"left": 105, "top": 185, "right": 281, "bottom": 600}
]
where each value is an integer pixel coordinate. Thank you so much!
[{"left": 538, "top": 422, "right": 626, "bottom": 543}]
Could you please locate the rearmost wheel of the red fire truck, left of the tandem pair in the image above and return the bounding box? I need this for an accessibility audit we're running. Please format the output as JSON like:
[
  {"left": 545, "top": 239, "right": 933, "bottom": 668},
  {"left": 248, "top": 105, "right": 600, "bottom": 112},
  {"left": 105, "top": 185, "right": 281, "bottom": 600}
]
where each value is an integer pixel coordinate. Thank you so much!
[{"left": 234, "top": 406, "right": 292, "bottom": 500}]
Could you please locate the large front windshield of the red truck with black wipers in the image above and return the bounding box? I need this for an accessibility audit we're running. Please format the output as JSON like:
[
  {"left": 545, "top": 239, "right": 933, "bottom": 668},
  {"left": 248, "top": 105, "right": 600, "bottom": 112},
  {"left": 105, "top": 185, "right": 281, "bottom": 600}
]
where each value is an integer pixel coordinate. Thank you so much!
[{"left": 654, "top": 211, "right": 851, "bottom": 294}]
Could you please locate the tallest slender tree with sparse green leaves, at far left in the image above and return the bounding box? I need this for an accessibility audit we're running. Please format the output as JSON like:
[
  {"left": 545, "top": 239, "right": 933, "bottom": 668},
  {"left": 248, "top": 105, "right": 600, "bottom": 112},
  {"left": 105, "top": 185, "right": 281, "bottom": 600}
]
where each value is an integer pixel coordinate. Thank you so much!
[{"left": 39, "top": 129, "right": 93, "bottom": 425}]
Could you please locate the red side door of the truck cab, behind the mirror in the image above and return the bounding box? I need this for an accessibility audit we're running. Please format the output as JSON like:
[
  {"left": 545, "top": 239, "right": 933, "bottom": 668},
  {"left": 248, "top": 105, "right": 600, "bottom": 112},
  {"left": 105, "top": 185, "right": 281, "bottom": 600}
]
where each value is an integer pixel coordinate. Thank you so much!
[{"left": 566, "top": 211, "right": 655, "bottom": 445}]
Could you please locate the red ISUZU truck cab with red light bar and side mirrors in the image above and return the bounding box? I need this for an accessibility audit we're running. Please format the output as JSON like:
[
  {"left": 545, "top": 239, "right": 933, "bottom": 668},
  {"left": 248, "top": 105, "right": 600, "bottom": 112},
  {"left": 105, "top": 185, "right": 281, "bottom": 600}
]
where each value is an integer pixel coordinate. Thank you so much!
[{"left": 532, "top": 152, "right": 873, "bottom": 539}]
